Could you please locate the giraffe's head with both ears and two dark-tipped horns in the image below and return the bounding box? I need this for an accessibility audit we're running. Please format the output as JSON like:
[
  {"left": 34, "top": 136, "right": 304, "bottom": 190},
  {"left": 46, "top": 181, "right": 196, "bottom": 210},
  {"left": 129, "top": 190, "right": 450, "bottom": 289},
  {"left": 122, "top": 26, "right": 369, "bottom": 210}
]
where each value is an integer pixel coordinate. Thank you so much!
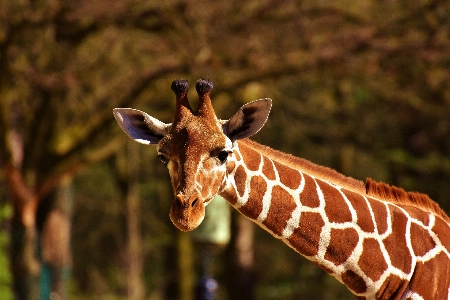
[{"left": 114, "top": 79, "right": 272, "bottom": 231}]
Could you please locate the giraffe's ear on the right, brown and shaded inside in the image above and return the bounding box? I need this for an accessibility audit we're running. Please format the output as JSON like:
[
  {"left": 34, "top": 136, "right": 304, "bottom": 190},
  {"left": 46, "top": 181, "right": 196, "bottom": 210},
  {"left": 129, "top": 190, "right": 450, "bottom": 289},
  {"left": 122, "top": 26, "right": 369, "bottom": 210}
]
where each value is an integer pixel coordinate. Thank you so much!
[{"left": 223, "top": 98, "right": 272, "bottom": 142}]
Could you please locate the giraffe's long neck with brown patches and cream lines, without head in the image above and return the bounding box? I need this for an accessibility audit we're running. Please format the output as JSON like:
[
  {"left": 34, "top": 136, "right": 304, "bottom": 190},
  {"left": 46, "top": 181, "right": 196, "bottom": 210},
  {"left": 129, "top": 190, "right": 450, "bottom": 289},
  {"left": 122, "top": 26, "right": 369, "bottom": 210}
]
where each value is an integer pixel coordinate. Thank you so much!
[{"left": 221, "top": 140, "right": 450, "bottom": 299}]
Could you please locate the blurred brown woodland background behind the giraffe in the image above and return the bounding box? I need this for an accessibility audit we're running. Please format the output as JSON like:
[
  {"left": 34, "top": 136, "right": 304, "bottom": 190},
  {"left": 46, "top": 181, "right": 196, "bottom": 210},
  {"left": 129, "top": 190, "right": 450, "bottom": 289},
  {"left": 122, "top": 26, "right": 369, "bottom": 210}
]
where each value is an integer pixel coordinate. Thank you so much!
[{"left": 0, "top": 0, "right": 450, "bottom": 300}]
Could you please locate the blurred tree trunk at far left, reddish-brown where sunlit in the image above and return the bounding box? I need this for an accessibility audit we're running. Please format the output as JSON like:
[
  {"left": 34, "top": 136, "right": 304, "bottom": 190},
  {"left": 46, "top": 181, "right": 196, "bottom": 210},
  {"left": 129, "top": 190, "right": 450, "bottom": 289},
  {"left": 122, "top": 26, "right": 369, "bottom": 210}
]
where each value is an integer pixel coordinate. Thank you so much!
[{"left": 2, "top": 96, "right": 40, "bottom": 300}]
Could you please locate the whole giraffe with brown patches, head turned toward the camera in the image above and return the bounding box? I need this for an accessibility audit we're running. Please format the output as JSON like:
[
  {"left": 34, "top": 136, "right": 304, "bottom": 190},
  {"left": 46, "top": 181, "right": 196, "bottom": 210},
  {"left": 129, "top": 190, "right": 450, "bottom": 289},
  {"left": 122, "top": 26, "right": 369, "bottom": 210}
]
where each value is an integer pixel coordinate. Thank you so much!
[{"left": 114, "top": 79, "right": 450, "bottom": 300}]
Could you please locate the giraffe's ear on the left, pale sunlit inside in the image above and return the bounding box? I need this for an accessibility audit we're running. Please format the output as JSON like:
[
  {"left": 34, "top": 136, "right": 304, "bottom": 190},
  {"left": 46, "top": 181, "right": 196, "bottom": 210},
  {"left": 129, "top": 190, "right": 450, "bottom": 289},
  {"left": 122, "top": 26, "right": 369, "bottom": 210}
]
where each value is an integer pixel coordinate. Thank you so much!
[{"left": 113, "top": 108, "right": 171, "bottom": 145}]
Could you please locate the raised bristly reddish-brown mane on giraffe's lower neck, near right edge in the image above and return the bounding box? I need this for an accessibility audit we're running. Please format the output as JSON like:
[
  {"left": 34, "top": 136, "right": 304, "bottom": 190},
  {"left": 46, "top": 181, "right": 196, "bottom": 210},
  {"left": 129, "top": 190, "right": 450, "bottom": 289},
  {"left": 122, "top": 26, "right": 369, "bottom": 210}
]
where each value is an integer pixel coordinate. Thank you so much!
[{"left": 365, "top": 178, "right": 450, "bottom": 222}]
